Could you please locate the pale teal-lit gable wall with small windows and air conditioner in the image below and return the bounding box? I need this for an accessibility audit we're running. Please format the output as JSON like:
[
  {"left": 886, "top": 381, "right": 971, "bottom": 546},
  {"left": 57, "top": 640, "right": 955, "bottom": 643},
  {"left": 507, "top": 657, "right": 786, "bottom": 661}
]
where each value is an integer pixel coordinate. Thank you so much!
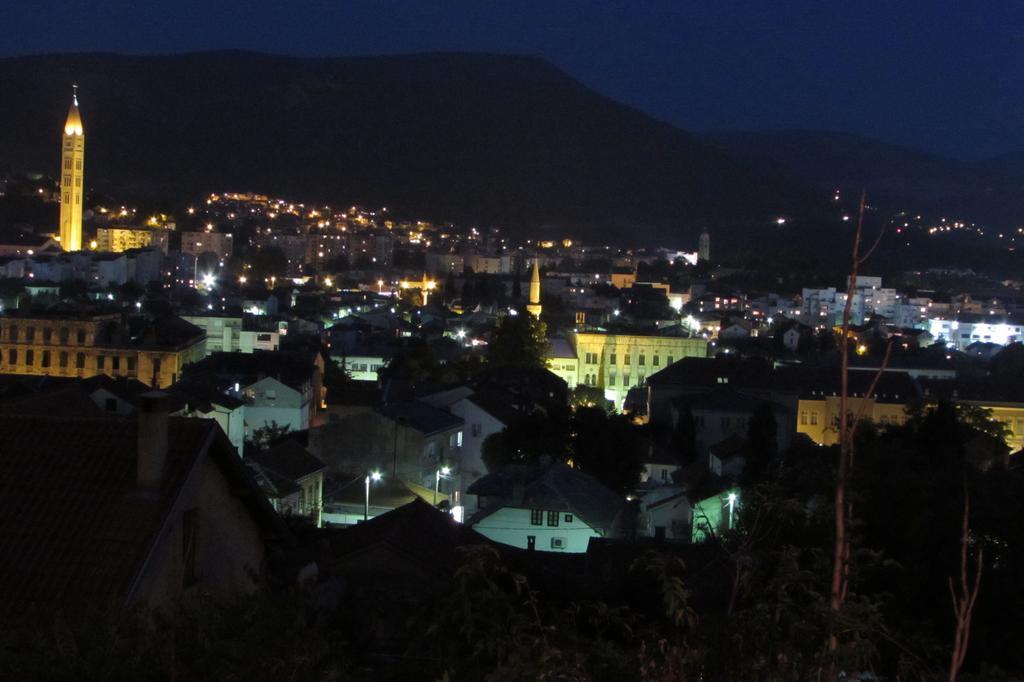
[{"left": 473, "top": 507, "right": 602, "bottom": 553}]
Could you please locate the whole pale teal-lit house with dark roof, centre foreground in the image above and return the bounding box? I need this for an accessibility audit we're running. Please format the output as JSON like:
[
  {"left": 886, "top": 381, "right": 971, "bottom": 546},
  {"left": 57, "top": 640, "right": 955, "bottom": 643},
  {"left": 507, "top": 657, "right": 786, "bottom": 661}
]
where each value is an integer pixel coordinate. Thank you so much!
[{"left": 466, "top": 464, "right": 625, "bottom": 553}]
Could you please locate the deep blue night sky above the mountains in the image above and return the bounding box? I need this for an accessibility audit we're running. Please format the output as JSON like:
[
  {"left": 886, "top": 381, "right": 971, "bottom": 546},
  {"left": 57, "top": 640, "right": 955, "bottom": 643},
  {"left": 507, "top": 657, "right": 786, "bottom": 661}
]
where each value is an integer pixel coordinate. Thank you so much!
[{"left": 0, "top": 0, "right": 1024, "bottom": 159}]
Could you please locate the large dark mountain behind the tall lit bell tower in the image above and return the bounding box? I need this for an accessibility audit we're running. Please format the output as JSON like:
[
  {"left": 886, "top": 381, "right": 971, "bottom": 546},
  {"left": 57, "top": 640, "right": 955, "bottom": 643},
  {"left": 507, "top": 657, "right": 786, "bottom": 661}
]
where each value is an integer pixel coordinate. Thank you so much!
[{"left": 0, "top": 52, "right": 824, "bottom": 246}]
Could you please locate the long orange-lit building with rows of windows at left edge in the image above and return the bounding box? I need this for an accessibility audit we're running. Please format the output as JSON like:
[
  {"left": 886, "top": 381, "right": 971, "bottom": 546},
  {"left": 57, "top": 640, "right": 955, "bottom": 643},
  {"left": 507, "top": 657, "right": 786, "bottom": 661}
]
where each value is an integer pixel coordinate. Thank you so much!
[{"left": 0, "top": 313, "right": 206, "bottom": 388}]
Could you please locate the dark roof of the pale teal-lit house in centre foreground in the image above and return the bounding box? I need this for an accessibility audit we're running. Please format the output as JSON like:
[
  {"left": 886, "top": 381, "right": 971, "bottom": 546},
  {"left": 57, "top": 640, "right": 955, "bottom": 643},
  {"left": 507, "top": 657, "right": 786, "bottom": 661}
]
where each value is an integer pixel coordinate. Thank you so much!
[{"left": 466, "top": 463, "right": 624, "bottom": 529}]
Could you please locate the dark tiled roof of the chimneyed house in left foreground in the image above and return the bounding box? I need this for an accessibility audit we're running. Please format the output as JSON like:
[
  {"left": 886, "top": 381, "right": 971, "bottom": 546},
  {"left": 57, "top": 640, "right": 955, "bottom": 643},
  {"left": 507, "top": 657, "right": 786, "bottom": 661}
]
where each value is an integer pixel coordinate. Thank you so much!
[{"left": 0, "top": 415, "right": 278, "bottom": 613}]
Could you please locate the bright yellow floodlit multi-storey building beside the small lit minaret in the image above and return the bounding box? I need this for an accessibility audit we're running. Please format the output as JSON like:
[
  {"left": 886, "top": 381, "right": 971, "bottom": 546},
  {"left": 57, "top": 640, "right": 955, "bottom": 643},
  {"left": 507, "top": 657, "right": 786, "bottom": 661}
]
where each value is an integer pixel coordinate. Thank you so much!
[{"left": 559, "top": 332, "right": 708, "bottom": 408}]
